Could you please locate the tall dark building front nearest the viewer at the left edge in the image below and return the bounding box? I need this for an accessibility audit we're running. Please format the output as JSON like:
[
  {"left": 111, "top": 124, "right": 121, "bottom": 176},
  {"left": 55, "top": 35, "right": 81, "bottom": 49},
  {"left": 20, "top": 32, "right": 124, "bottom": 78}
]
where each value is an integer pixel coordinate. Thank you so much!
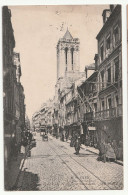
[{"left": 2, "top": 6, "right": 16, "bottom": 168}]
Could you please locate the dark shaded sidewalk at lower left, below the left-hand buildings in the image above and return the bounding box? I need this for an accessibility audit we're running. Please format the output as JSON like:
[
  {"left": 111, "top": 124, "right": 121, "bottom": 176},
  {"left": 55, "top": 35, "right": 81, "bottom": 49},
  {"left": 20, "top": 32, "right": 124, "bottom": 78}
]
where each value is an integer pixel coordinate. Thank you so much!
[{"left": 4, "top": 145, "right": 29, "bottom": 191}]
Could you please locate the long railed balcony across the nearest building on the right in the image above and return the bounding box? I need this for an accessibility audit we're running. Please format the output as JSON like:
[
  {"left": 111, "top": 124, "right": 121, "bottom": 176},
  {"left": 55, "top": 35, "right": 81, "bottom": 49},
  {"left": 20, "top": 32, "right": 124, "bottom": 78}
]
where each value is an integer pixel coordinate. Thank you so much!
[{"left": 94, "top": 105, "right": 122, "bottom": 120}]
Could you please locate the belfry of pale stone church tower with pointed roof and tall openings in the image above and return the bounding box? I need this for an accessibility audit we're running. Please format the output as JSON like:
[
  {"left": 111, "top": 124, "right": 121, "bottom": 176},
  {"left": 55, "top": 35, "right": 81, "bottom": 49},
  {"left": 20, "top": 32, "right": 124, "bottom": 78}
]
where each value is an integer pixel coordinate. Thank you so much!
[{"left": 57, "top": 29, "right": 80, "bottom": 79}]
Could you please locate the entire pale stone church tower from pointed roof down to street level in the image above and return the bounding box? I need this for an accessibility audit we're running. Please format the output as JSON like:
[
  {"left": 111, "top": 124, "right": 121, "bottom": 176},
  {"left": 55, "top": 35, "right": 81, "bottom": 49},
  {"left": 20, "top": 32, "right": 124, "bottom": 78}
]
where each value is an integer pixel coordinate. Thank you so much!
[{"left": 55, "top": 29, "right": 85, "bottom": 136}]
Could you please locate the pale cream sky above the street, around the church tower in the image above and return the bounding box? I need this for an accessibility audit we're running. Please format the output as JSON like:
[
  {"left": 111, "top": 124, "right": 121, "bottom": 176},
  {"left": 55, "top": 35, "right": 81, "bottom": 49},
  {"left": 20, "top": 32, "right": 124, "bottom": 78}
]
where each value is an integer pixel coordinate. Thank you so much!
[{"left": 9, "top": 5, "right": 109, "bottom": 118}]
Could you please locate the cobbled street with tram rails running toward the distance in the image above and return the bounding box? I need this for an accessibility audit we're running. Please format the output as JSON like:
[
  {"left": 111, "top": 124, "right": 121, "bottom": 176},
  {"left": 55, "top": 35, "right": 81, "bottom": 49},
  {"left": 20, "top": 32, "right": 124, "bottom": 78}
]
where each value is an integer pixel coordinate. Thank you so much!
[{"left": 18, "top": 134, "right": 123, "bottom": 191}]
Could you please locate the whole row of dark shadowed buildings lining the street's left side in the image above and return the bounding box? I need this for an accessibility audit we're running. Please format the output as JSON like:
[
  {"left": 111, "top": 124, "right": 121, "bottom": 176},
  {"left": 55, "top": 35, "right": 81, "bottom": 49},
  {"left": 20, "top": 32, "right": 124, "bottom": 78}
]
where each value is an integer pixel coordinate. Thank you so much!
[{"left": 2, "top": 6, "right": 25, "bottom": 170}]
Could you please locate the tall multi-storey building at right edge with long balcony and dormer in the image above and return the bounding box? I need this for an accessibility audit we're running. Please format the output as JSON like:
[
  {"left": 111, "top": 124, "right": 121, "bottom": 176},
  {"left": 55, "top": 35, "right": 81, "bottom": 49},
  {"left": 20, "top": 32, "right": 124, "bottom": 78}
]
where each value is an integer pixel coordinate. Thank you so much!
[{"left": 94, "top": 5, "right": 123, "bottom": 152}]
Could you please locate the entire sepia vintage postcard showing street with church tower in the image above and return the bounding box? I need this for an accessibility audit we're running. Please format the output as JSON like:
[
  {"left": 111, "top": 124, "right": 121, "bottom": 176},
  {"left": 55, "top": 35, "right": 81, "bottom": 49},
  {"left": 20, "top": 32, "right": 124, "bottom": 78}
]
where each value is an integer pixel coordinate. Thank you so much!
[{"left": 2, "top": 4, "right": 124, "bottom": 191}]
